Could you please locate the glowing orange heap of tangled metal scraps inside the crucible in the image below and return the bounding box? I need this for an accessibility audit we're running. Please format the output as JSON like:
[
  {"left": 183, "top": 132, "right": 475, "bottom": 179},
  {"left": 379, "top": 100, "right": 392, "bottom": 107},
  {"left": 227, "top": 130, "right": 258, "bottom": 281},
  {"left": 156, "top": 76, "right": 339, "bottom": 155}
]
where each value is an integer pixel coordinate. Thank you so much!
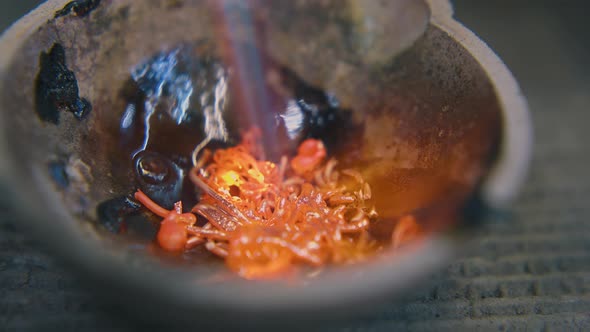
[{"left": 135, "top": 129, "right": 420, "bottom": 279}]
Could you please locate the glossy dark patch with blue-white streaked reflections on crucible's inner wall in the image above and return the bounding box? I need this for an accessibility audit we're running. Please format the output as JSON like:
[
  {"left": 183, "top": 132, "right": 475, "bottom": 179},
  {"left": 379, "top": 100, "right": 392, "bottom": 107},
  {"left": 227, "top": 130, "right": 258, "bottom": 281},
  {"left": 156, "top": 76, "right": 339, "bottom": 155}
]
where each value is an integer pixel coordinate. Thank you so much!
[{"left": 115, "top": 41, "right": 232, "bottom": 159}]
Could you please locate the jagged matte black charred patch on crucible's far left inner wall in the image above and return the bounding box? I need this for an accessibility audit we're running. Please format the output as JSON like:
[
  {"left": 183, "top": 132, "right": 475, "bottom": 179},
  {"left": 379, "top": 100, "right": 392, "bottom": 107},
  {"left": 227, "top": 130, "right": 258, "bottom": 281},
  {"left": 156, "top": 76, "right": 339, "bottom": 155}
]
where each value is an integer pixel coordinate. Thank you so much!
[{"left": 35, "top": 43, "right": 92, "bottom": 124}]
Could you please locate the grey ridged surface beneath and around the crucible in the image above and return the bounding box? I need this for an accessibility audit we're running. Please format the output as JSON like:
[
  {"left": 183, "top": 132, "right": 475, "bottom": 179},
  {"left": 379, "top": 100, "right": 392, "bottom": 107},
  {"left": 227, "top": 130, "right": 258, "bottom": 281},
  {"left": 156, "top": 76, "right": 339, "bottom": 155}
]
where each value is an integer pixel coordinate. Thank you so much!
[{"left": 0, "top": 0, "right": 590, "bottom": 331}]
